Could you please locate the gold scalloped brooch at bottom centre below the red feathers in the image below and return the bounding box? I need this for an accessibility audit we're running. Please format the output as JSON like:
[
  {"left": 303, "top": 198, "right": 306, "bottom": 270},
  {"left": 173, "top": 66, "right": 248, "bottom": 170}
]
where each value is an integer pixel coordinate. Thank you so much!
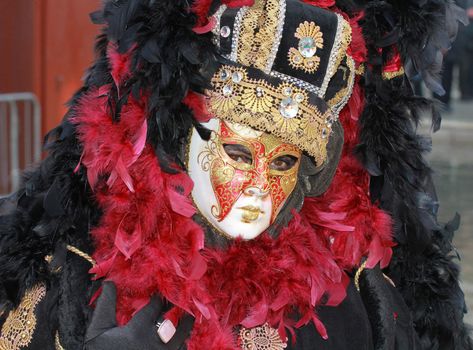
[{"left": 240, "top": 323, "right": 287, "bottom": 350}]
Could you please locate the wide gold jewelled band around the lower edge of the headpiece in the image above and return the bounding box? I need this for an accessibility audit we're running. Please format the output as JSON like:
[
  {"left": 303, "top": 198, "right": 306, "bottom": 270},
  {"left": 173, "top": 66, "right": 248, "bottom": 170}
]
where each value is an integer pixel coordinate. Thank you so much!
[{"left": 207, "top": 66, "right": 333, "bottom": 164}]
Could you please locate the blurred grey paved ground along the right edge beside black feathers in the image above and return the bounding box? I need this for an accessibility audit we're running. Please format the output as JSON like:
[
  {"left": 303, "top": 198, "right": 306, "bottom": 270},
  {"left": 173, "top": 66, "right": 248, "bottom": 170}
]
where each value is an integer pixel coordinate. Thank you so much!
[{"left": 424, "top": 98, "right": 473, "bottom": 325}]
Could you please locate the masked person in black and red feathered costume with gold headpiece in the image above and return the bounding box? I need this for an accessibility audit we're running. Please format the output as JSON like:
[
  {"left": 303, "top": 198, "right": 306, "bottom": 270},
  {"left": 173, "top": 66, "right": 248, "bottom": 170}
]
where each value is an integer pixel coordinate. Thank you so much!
[{"left": 0, "top": 0, "right": 472, "bottom": 350}]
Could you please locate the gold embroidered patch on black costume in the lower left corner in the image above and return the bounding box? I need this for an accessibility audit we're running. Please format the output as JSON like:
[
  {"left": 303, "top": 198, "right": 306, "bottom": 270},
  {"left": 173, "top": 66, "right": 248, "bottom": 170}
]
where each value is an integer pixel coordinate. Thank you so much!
[{"left": 0, "top": 284, "right": 46, "bottom": 350}]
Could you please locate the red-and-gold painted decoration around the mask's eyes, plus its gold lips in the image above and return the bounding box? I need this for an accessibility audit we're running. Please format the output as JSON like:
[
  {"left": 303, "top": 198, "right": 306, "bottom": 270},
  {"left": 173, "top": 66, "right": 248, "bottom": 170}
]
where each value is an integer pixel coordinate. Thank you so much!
[{"left": 198, "top": 121, "right": 301, "bottom": 223}]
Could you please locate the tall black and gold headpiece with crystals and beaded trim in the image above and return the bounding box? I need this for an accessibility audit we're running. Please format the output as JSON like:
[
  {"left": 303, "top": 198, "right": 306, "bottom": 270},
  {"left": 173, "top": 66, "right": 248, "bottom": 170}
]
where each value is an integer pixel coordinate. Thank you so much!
[{"left": 208, "top": 0, "right": 355, "bottom": 164}]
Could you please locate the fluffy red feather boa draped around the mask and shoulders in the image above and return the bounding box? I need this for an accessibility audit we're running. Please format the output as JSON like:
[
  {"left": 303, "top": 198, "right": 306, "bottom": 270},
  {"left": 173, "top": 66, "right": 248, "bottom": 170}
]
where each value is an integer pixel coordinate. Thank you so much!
[{"left": 73, "top": 7, "right": 393, "bottom": 349}]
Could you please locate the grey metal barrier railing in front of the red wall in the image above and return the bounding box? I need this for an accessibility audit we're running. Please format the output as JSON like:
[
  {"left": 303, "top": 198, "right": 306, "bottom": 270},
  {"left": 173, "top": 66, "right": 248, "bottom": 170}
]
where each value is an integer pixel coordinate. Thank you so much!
[{"left": 0, "top": 92, "right": 41, "bottom": 195}]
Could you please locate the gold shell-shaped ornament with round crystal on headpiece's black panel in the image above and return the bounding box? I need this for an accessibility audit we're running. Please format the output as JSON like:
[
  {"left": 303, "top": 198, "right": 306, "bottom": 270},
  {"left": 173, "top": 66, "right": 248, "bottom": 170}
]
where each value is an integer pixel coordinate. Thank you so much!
[{"left": 288, "top": 21, "right": 324, "bottom": 73}]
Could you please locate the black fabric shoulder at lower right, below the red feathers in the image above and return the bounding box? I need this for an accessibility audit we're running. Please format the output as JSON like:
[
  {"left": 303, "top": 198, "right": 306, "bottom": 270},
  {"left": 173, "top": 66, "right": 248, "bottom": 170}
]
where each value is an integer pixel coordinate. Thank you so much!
[{"left": 287, "top": 274, "right": 421, "bottom": 350}]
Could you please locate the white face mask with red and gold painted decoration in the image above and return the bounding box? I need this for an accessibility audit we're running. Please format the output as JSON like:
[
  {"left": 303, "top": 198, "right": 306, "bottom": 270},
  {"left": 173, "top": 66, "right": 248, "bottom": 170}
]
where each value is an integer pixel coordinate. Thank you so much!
[{"left": 187, "top": 118, "right": 301, "bottom": 240}]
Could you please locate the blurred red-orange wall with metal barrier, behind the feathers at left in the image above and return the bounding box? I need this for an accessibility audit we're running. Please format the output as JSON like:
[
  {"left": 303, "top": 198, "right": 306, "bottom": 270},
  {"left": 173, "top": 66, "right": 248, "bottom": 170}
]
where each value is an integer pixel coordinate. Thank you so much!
[{"left": 0, "top": 0, "right": 101, "bottom": 195}]
